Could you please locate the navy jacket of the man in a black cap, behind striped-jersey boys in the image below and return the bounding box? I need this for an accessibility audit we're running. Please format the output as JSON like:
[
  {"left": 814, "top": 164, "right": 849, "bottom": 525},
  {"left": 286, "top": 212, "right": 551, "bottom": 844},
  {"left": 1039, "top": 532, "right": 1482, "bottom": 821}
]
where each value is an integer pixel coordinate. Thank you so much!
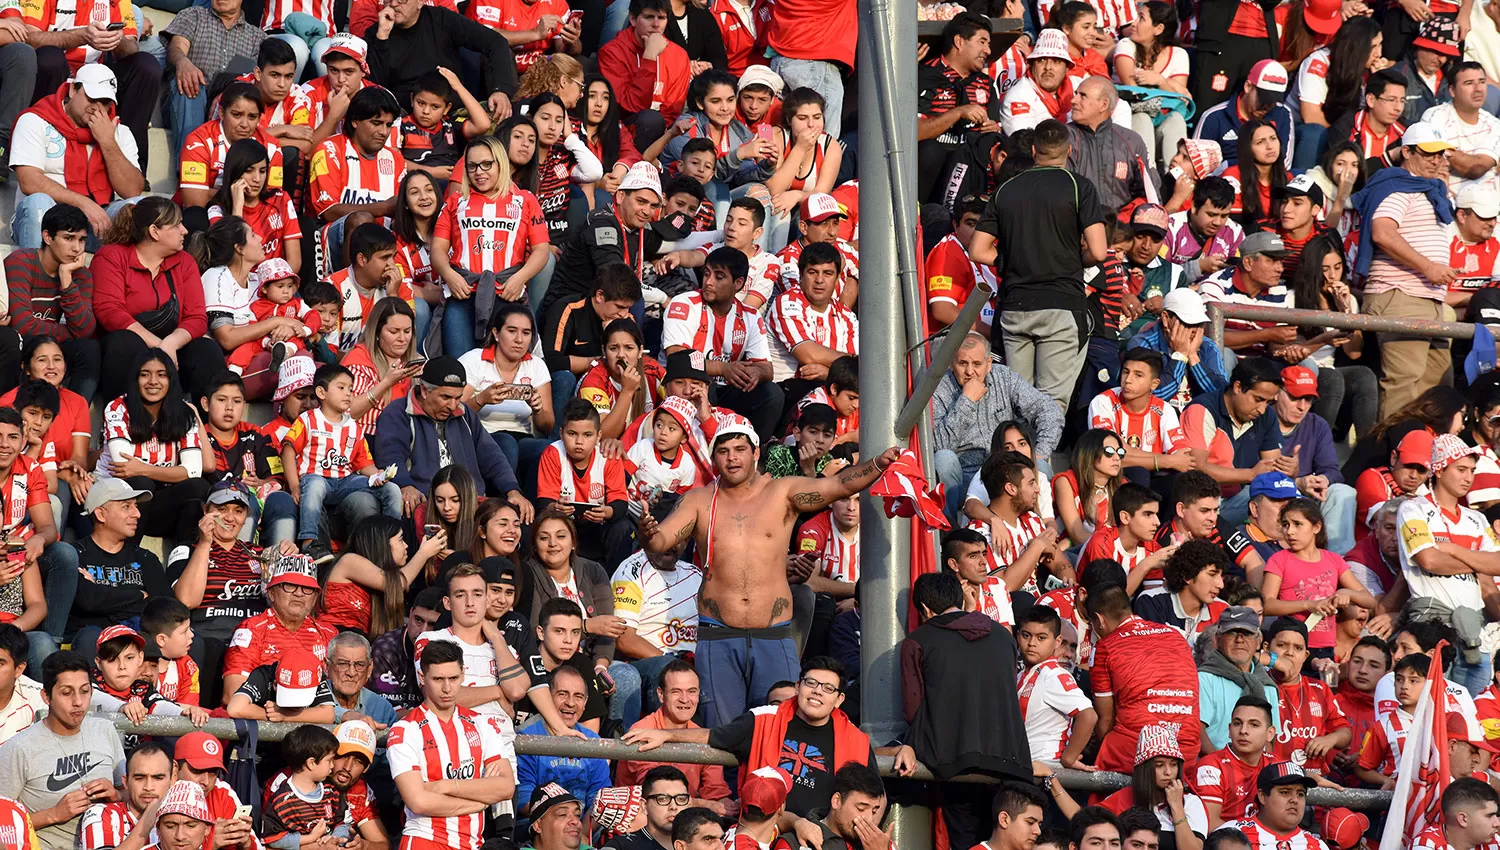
[{"left": 371, "top": 390, "right": 527, "bottom": 497}]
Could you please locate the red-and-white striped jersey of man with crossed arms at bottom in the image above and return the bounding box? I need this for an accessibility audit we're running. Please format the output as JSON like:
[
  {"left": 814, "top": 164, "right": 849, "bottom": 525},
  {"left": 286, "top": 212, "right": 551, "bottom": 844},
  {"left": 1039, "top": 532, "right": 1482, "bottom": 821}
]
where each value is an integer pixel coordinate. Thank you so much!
[{"left": 386, "top": 703, "right": 507, "bottom": 850}]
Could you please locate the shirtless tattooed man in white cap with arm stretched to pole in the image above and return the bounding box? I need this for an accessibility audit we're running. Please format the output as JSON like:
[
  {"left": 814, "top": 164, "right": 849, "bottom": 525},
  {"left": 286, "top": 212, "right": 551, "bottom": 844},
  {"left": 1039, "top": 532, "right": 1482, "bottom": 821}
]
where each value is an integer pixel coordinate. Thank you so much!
[{"left": 641, "top": 417, "right": 900, "bottom": 727}]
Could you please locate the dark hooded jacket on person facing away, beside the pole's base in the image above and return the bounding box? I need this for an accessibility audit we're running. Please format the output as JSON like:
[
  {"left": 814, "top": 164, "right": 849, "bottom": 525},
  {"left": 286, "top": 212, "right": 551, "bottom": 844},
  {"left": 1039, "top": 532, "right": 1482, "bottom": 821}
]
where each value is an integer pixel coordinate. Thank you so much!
[{"left": 902, "top": 612, "right": 1032, "bottom": 781}]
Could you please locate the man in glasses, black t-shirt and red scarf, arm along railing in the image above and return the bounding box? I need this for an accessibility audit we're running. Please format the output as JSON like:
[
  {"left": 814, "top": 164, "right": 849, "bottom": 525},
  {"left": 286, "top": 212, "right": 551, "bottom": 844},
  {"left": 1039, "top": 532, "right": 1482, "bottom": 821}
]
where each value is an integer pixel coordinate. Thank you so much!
[{"left": 624, "top": 657, "right": 876, "bottom": 837}]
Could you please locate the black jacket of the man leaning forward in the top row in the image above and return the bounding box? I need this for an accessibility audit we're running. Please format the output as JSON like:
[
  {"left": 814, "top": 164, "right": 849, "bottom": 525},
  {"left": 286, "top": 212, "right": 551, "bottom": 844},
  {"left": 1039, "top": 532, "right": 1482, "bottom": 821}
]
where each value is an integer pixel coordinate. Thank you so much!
[{"left": 365, "top": 6, "right": 519, "bottom": 103}]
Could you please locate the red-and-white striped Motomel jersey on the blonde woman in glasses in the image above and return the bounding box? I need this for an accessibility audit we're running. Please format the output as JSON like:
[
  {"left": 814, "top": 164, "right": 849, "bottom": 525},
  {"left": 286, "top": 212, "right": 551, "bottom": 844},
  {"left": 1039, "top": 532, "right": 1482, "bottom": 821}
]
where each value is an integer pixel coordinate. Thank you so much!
[{"left": 432, "top": 186, "right": 548, "bottom": 271}]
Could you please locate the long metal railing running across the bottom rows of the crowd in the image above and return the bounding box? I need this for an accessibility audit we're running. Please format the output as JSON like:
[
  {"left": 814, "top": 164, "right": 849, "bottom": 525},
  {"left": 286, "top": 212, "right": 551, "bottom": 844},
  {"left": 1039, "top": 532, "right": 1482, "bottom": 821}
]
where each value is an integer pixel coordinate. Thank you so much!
[{"left": 105, "top": 714, "right": 1391, "bottom": 811}]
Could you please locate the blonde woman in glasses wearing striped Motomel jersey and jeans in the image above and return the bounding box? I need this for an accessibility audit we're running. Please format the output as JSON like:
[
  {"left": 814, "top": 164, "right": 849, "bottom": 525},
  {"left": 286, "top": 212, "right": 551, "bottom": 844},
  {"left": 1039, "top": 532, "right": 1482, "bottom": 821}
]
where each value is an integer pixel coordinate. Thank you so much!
[{"left": 432, "top": 136, "right": 552, "bottom": 357}]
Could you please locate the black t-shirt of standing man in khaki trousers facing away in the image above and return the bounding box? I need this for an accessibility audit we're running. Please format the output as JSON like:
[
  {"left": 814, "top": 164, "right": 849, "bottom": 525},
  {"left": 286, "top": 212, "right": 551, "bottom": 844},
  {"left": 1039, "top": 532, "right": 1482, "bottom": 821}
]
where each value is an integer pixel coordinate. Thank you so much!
[{"left": 978, "top": 166, "right": 1104, "bottom": 313}]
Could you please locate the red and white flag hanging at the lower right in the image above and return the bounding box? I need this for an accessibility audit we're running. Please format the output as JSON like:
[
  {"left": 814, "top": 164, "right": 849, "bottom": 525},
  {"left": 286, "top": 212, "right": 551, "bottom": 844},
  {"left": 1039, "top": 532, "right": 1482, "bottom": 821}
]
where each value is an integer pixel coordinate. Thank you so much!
[{"left": 1380, "top": 642, "right": 1452, "bottom": 850}]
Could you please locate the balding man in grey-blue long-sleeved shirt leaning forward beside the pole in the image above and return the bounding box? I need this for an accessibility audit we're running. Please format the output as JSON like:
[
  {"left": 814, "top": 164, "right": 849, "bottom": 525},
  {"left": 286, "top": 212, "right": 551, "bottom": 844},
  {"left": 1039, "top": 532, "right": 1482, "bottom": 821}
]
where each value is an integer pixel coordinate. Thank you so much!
[{"left": 933, "top": 333, "right": 1062, "bottom": 514}]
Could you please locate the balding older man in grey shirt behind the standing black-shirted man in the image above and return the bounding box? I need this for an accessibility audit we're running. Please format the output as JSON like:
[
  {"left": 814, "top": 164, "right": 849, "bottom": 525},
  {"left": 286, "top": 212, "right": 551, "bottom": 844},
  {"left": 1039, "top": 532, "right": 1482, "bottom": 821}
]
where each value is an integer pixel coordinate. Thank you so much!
[{"left": 1068, "top": 76, "right": 1161, "bottom": 210}]
